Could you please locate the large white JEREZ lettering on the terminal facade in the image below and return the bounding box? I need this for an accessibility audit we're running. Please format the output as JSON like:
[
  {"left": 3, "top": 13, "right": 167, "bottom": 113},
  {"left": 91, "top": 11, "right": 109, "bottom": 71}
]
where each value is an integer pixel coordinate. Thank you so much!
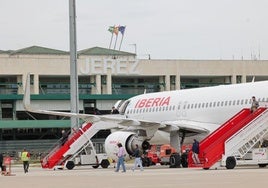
[{"left": 79, "top": 58, "right": 139, "bottom": 75}]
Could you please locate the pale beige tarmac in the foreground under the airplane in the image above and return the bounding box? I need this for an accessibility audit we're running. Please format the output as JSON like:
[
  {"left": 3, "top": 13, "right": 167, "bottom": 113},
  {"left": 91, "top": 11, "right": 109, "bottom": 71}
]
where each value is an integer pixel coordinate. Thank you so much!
[{"left": 0, "top": 164, "right": 268, "bottom": 188}]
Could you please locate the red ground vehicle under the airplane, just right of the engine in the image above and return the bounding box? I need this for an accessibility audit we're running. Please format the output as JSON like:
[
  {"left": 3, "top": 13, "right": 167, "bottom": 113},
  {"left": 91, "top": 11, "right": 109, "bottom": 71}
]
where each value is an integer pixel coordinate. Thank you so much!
[{"left": 142, "top": 144, "right": 176, "bottom": 166}]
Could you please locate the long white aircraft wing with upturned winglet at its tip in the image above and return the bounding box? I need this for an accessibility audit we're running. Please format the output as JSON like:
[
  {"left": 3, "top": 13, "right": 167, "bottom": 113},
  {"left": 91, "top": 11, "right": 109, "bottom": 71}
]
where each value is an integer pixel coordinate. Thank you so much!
[{"left": 23, "top": 75, "right": 209, "bottom": 133}]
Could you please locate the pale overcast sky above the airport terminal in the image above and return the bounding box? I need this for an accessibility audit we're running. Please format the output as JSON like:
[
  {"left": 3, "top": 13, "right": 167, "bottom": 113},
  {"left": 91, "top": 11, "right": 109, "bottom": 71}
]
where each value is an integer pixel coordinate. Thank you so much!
[{"left": 0, "top": 0, "right": 268, "bottom": 60}]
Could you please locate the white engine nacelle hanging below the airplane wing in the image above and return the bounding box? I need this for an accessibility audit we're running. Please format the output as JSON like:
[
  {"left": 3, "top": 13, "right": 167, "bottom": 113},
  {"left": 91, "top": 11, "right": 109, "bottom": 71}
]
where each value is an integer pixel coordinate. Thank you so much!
[{"left": 105, "top": 131, "right": 150, "bottom": 160}]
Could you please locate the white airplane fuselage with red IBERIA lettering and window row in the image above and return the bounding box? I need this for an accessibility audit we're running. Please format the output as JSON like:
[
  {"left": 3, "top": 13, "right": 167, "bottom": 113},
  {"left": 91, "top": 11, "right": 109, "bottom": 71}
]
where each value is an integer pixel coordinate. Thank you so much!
[{"left": 119, "top": 81, "right": 268, "bottom": 144}]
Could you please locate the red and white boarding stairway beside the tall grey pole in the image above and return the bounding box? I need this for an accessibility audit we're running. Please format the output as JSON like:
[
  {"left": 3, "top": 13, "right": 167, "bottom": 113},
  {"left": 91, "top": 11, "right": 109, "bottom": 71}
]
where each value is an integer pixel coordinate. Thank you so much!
[{"left": 41, "top": 123, "right": 100, "bottom": 169}]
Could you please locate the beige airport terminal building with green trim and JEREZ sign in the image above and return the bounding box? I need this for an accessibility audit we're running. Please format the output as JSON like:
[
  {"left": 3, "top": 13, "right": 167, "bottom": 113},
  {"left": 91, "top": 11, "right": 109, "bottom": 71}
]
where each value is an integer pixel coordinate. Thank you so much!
[{"left": 0, "top": 46, "right": 268, "bottom": 155}]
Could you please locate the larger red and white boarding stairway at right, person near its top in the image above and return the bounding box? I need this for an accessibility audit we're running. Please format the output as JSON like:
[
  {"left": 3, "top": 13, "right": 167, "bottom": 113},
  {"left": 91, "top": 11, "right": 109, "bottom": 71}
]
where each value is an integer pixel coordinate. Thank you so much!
[{"left": 188, "top": 107, "right": 268, "bottom": 169}]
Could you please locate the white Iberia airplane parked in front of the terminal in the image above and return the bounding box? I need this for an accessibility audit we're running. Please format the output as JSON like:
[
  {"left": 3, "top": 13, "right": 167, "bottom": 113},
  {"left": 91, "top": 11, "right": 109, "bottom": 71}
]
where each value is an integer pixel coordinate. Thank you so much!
[{"left": 23, "top": 73, "right": 268, "bottom": 163}]
